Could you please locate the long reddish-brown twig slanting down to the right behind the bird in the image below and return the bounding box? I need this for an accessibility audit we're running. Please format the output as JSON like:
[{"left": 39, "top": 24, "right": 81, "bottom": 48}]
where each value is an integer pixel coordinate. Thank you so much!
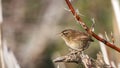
[{"left": 65, "top": 0, "right": 120, "bottom": 52}]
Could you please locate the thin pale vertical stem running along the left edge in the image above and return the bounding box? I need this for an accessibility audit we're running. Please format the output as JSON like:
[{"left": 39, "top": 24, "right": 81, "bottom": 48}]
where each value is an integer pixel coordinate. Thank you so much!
[{"left": 0, "top": 0, "right": 5, "bottom": 68}]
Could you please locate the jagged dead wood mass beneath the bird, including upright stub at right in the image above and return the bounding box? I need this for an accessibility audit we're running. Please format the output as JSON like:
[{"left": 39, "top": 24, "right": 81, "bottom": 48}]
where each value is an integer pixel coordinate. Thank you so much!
[{"left": 53, "top": 52, "right": 111, "bottom": 68}]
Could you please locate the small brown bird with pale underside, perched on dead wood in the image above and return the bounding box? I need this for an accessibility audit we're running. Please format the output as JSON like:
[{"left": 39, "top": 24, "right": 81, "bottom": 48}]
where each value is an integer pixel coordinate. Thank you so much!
[{"left": 59, "top": 29, "right": 94, "bottom": 51}]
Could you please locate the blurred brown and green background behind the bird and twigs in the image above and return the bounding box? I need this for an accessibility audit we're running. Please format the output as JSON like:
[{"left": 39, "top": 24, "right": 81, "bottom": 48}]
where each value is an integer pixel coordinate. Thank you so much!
[{"left": 2, "top": 0, "right": 120, "bottom": 68}]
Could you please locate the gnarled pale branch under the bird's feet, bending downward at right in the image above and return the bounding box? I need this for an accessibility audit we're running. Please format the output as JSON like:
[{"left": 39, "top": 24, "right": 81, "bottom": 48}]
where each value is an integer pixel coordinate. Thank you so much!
[{"left": 53, "top": 52, "right": 95, "bottom": 68}]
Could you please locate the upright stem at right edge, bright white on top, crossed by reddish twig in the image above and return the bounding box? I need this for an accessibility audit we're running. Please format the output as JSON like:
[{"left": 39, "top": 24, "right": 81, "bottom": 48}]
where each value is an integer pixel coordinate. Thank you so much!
[{"left": 111, "top": 0, "right": 120, "bottom": 68}]
